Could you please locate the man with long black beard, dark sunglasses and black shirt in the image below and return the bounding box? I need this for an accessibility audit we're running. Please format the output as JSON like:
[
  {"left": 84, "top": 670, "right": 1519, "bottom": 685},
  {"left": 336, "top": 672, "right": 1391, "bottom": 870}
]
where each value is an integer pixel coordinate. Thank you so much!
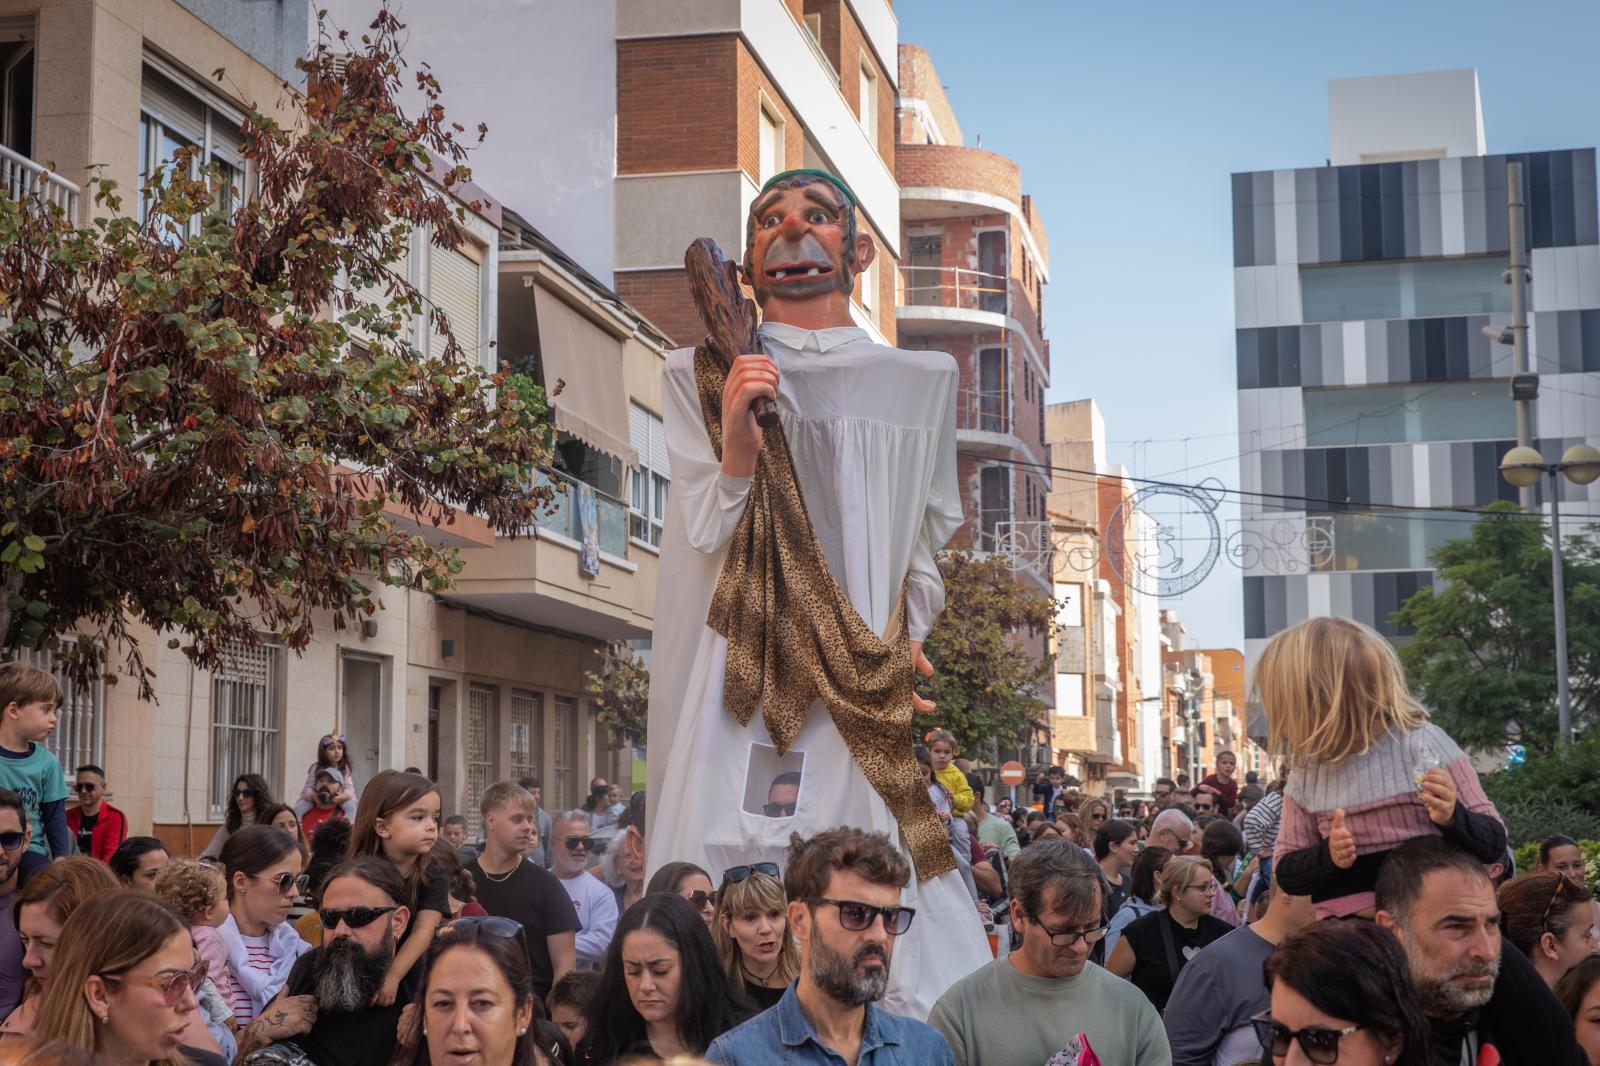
[{"left": 237, "top": 856, "right": 411, "bottom": 1066}]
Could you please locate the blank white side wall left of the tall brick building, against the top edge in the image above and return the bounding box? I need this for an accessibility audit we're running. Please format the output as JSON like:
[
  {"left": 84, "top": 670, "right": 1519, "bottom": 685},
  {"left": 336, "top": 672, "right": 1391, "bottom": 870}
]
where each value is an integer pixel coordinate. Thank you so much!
[{"left": 318, "top": 0, "right": 616, "bottom": 285}]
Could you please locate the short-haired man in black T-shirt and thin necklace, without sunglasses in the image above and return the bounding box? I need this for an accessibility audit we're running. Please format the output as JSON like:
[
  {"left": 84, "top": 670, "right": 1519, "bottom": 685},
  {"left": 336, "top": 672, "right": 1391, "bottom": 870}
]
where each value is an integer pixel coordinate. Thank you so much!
[{"left": 467, "top": 781, "right": 579, "bottom": 1000}]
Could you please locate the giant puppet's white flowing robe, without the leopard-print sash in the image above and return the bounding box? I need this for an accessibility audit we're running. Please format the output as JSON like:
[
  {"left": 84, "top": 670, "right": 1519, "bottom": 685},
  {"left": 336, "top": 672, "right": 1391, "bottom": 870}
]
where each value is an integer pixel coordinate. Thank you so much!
[{"left": 648, "top": 323, "right": 992, "bottom": 1018}]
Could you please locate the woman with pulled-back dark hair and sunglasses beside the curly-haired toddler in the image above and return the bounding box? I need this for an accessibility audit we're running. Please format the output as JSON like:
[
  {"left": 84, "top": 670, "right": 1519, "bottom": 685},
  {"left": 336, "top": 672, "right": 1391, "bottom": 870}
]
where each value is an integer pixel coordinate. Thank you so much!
[{"left": 216, "top": 826, "right": 310, "bottom": 1026}]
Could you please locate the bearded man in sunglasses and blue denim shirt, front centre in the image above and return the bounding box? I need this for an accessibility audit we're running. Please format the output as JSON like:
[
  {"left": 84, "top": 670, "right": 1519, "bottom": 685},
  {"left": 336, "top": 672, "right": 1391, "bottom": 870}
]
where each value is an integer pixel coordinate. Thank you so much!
[{"left": 706, "top": 829, "right": 947, "bottom": 1066}]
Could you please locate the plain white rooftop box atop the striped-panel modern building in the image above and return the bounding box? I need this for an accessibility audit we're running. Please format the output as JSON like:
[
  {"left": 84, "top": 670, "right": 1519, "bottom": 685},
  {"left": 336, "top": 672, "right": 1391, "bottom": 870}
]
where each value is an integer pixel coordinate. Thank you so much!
[{"left": 1328, "top": 69, "right": 1485, "bottom": 166}]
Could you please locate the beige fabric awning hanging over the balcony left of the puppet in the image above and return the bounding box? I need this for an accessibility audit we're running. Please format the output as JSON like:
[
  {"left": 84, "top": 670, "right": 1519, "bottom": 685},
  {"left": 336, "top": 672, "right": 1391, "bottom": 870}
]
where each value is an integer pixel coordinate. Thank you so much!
[{"left": 533, "top": 285, "right": 638, "bottom": 467}]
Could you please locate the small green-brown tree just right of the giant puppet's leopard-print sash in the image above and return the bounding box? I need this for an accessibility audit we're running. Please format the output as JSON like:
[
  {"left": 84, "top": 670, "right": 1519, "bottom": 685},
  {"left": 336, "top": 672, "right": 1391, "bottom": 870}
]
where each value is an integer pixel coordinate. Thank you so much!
[{"left": 915, "top": 552, "right": 1056, "bottom": 760}]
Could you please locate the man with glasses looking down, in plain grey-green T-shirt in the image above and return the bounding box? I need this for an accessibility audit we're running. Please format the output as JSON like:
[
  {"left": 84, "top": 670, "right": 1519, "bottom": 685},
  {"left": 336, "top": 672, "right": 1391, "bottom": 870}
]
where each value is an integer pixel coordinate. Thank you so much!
[{"left": 928, "top": 840, "right": 1173, "bottom": 1066}]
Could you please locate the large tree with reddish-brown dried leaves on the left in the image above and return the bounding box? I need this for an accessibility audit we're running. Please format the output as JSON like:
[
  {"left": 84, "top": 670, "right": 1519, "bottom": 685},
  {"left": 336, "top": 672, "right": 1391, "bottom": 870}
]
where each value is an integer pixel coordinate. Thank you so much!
[{"left": 0, "top": 10, "right": 550, "bottom": 695}]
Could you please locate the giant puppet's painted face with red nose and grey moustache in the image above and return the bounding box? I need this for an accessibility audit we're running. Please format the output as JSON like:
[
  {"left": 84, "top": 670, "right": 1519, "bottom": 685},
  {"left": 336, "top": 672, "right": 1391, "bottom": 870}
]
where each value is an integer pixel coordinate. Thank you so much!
[{"left": 744, "top": 181, "right": 872, "bottom": 307}]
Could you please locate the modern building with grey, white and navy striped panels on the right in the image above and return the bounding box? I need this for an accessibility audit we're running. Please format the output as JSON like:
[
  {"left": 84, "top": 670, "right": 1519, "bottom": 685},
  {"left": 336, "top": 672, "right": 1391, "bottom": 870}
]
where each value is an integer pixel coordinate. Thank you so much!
[{"left": 1234, "top": 70, "right": 1600, "bottom": 672}]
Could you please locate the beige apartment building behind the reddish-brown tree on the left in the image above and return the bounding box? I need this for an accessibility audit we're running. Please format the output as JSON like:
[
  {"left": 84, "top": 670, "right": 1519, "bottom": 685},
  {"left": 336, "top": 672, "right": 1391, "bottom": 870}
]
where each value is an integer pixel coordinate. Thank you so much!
[{"left": 0, "top": 0, "right": 670, "bottom": 853}]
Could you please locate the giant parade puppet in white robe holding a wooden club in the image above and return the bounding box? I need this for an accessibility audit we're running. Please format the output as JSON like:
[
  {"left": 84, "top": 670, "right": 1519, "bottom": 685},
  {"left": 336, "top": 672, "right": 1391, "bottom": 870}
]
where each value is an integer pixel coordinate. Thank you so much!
[{"left": 648, "top": 170, "right": 992, "bottom": 1018}]
